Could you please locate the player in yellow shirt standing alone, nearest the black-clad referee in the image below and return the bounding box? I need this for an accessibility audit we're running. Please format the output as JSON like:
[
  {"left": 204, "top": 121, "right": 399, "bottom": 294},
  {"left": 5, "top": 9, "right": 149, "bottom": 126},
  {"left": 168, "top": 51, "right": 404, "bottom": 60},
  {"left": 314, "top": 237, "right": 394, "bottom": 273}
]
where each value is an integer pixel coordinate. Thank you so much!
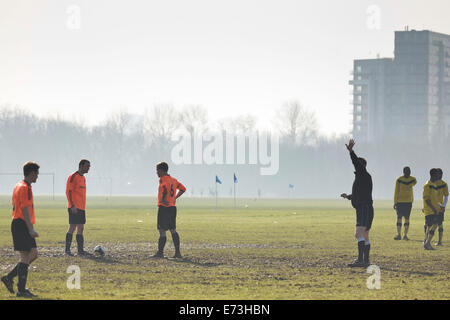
[{"left": 394, "top": 167, "right": 417, "bottom": 240}]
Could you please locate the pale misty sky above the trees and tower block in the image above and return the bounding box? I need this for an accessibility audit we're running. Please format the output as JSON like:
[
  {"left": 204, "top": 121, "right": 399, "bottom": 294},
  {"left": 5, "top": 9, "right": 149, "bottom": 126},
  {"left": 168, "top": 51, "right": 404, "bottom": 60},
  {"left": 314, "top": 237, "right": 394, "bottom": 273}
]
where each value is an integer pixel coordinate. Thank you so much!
[{"left": 0, "top": 0, "right": 450, "bottom": 134}]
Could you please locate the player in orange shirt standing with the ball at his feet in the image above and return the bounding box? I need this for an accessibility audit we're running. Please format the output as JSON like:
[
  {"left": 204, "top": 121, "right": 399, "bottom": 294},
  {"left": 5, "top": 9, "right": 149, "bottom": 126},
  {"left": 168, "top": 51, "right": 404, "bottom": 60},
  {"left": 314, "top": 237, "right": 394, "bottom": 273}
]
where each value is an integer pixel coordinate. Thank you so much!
[{"left": 65, "top": 159, "right": 91, "bottom": 256}]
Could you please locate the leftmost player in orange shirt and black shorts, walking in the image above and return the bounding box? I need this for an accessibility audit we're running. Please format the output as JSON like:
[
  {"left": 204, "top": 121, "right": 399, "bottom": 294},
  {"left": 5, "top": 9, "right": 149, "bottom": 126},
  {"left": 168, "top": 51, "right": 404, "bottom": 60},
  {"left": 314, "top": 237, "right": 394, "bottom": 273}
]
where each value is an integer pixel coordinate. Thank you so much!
[{"left": 1, "top": 162, "right": 39, "bottom": 298}]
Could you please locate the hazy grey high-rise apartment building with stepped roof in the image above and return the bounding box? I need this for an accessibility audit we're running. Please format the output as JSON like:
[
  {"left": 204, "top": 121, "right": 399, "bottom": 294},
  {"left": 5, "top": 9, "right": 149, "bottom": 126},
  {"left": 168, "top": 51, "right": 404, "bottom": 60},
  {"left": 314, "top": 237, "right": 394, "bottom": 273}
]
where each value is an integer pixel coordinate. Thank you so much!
[{"left": 350, "top": 30, "right": 450, "bottom": 143}]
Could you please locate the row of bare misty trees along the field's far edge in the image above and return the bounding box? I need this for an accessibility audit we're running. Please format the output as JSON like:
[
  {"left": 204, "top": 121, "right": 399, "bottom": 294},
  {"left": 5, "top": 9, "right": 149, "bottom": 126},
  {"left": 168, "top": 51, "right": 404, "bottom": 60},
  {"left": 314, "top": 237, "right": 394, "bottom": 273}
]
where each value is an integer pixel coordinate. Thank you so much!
[{"left": 0, "top": 101, "right": 450, "bottom": 198}]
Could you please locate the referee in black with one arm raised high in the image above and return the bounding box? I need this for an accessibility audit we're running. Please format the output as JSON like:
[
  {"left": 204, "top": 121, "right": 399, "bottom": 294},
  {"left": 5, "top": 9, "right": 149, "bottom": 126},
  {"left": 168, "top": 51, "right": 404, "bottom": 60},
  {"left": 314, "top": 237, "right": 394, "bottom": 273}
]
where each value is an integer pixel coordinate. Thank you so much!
[{"left": 341, "top": 139, "right": 374, "bottom": 267}]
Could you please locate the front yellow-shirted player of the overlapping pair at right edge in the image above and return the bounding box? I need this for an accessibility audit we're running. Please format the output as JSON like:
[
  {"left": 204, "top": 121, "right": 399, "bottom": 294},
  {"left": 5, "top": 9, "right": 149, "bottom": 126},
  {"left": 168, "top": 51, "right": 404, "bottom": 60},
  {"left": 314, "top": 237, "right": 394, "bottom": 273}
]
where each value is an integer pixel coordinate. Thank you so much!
[{"left": 423, "top": 169, "right": 445, "bottom": 250}]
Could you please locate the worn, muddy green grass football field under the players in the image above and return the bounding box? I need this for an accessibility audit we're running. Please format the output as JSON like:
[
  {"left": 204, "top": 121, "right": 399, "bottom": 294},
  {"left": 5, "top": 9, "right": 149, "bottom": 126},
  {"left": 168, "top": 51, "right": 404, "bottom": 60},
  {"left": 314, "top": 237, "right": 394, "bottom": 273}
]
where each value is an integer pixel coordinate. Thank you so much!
[{"left": 0, "top": 196, "right": 450, "bottom": 300}]
